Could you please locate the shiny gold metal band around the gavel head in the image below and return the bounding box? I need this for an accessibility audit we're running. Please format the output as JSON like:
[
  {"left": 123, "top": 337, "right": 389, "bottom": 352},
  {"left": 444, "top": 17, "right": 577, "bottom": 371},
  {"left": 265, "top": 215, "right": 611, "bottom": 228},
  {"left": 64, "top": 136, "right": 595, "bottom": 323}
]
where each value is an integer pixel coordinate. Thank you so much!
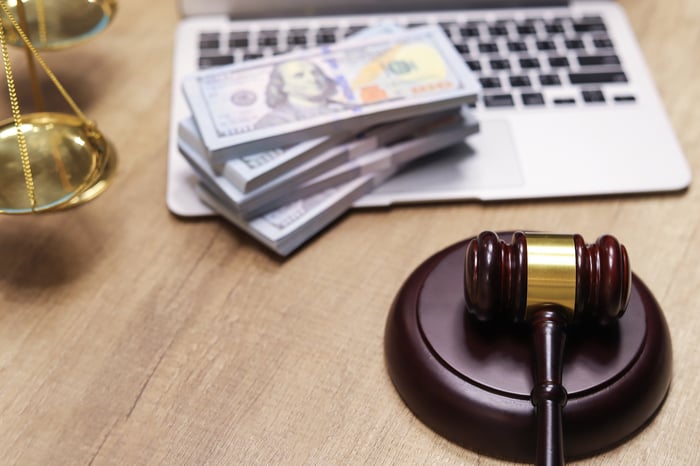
[{"left": 525, "top": 233, "right": 576, "bottom": 319}]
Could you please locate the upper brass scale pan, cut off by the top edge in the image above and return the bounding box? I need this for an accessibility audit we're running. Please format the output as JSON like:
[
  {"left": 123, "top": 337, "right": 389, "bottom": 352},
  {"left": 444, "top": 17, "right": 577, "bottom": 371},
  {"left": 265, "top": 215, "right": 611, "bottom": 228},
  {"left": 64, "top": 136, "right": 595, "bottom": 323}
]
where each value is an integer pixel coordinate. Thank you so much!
[{"left": 3, "top": 0, "right": 117, "bottom": 50}]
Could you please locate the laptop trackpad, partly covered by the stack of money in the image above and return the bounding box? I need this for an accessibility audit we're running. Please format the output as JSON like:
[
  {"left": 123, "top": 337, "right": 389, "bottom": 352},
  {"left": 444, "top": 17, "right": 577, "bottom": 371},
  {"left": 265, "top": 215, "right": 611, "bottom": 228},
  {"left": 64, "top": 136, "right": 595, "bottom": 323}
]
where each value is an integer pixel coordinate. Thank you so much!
[{"left": 354, "top": 119, "right": 524, "bottom": 207}]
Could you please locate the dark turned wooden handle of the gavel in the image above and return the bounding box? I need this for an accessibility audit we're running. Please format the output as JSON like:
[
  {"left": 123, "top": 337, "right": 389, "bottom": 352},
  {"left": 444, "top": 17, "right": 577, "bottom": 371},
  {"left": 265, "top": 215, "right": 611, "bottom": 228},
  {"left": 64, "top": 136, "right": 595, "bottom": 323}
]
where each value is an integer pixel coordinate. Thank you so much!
[{"left": 530, "top": 307, "right": 567, "bottom": 466}]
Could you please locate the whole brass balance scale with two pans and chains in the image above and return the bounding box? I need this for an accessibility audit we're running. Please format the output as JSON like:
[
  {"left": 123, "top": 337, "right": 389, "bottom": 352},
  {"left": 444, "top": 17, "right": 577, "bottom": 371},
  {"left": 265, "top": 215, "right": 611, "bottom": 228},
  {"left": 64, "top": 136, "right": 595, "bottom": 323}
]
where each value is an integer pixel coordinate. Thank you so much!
[{"left": 0, "top": 0, "right": 117, "bottom": 214}]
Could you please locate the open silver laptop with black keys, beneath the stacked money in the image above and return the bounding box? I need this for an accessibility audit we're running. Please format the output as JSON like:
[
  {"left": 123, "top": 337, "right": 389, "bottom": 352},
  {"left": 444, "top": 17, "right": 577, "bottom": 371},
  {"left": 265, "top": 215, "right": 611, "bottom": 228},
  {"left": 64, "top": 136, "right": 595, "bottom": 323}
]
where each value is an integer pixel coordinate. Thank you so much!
[{"left": 167, "top": 0, "right": 691, "bottom": 217}]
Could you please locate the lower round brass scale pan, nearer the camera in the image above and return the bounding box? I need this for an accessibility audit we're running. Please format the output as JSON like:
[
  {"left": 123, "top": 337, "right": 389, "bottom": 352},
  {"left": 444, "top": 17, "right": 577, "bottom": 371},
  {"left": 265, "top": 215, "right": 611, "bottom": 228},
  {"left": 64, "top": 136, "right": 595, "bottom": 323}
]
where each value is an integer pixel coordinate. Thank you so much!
[{"left": 0, "top": 113, "right": 114, "bottom": 214}]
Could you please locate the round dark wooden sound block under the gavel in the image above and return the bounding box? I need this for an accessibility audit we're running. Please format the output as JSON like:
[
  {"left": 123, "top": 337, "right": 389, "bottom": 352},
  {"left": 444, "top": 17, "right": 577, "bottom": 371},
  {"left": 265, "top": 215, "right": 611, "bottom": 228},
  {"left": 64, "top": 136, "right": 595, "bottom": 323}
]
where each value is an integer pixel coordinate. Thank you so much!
[{"left": 385, "top": 233, "right": 671, "bottom": 462}]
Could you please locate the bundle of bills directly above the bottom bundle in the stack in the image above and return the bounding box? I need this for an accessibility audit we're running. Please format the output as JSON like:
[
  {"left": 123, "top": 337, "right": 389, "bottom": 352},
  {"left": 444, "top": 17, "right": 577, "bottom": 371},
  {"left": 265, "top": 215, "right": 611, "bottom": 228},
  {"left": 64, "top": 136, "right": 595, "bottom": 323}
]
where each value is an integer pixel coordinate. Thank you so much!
[{"left": 180, "top": 108, "right": 478, "bottom": 218}]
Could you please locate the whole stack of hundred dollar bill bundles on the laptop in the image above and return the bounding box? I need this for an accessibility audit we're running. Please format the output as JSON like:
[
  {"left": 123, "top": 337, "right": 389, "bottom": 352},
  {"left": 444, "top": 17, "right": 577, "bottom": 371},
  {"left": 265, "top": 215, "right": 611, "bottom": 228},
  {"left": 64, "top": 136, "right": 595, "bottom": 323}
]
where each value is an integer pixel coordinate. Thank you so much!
[{"left": 178, "top": 26, "right": 480, "bottom": 256}]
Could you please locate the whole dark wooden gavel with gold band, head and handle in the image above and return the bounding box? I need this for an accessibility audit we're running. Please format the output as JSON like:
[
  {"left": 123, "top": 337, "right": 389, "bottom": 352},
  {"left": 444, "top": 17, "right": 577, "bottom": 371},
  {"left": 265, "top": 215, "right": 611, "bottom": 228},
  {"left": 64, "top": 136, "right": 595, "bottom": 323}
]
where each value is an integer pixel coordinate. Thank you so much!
[{"left": 464, "top": 231, "right": 632, "bottom": 466}]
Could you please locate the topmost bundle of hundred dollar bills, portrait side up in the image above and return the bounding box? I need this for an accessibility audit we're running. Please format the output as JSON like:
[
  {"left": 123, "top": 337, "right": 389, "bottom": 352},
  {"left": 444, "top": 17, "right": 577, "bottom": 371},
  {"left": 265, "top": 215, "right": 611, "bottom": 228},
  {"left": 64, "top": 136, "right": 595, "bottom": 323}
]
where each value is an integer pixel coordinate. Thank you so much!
[{"left": 183, "top": 26, "right": 480, "bottom": 164}]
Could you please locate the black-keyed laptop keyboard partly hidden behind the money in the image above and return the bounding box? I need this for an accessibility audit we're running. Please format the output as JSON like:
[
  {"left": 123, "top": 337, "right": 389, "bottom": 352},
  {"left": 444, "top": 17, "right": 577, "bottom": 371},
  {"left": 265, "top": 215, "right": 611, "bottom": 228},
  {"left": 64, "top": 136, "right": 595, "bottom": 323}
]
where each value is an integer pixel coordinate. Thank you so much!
[{"left": 194, "top": 15, "right": 636, "bottom": 110}]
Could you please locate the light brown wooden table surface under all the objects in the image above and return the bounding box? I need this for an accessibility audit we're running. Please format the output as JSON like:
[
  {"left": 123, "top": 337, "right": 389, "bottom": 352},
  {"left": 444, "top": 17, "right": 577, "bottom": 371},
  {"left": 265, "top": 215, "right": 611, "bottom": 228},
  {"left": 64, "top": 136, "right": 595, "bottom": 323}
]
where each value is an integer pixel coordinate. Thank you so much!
[{"left": 0, "top": 0, "right": 700, "bottom": 465}]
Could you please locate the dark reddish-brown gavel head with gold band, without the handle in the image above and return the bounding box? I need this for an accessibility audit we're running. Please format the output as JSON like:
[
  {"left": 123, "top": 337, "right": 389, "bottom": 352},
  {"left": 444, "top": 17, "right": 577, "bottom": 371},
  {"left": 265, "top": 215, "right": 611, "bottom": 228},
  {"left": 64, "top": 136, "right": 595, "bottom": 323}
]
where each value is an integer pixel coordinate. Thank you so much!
[{"left": 464, "top": 232, "right": 632, "bottom": 324}]
